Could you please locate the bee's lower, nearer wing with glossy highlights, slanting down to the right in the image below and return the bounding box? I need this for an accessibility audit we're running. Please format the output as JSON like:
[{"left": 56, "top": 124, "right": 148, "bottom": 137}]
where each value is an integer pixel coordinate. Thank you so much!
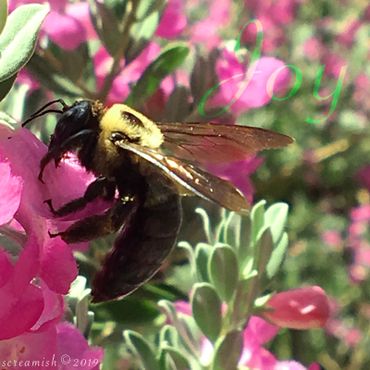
[{"left": 115, "top": 141, "right": 248, "bottom": 212}]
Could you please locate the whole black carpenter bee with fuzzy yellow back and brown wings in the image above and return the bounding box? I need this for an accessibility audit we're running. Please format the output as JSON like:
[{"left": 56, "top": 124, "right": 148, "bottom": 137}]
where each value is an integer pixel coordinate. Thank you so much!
[{"left": 23, "top": 99, "right": 292, "bottom": 302}]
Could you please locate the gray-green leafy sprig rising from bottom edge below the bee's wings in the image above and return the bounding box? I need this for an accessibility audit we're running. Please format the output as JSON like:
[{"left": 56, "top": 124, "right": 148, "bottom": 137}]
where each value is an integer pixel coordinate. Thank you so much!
[{"left": 125, "top": 201, "right": 288, "bottom": 370}]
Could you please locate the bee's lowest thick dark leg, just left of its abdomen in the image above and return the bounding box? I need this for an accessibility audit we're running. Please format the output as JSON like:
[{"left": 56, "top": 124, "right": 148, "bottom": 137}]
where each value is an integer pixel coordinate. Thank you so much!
[{"left": 49, "top": 198, "right": 137, "bottom": 243}]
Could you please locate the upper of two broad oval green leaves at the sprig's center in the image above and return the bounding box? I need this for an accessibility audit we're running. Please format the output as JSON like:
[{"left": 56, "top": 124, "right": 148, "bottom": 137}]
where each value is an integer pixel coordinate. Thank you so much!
[{"left": 208, "top": 245, "right": 239, "bottom": 302}]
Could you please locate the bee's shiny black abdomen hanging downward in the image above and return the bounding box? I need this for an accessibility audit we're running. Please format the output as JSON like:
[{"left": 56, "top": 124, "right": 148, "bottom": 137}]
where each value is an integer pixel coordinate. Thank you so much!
[{"left": 92, "top": 185, "right": 181, "bottom": 302}]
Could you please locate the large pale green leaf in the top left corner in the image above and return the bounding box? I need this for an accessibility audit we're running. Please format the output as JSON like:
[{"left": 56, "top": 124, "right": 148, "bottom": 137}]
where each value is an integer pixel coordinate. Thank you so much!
[{"left": 0, "top": 4, "right": 49, "bottom": 81}]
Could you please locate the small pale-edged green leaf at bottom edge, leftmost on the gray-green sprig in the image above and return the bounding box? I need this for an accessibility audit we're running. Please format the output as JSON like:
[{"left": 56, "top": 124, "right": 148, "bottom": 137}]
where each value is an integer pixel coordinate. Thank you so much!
[{"left": 123, "top": 330, "right": 160, "bottom": 370}]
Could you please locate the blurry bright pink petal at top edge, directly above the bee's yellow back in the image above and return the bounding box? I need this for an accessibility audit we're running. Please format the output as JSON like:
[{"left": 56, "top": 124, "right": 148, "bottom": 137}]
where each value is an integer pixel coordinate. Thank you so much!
[{"left": 156, "top": 0, "right": 187, "bottom": 39}]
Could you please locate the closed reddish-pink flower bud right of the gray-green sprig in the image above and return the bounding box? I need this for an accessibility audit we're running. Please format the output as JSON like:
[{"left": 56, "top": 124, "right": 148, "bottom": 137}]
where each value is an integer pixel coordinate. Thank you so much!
[{"left": 262, "top": 286, "right": 330, "bottom": 329}]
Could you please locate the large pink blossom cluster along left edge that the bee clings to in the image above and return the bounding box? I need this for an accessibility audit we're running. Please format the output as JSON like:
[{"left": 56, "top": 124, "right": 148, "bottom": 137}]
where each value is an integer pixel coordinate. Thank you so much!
[{"left": 0, "top": 124, "right": 103, "bottom": 369}]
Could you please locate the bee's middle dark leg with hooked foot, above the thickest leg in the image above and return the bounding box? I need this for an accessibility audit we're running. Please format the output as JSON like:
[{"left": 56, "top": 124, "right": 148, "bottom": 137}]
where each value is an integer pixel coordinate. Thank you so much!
[{"left": 44, "top": 177, "right": 116, "bottom": 217}]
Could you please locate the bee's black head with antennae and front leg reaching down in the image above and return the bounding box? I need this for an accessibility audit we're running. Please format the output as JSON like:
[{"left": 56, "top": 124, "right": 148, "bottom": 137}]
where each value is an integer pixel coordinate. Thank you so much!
[{"left": 23, "top": 100, "right": 104, "bottom": 181}]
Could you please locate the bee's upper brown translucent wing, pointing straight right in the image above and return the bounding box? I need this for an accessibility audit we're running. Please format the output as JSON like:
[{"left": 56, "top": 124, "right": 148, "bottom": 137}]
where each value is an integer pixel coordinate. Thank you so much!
[{"left": 157, "top": 123, "right": 293, "bottom": 167}]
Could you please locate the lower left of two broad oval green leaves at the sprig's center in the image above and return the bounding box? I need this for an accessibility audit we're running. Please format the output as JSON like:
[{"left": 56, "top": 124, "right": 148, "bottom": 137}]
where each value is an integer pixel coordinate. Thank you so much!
[{"left": 191, "top": 283, "right": 222, "bottom": 342}]
